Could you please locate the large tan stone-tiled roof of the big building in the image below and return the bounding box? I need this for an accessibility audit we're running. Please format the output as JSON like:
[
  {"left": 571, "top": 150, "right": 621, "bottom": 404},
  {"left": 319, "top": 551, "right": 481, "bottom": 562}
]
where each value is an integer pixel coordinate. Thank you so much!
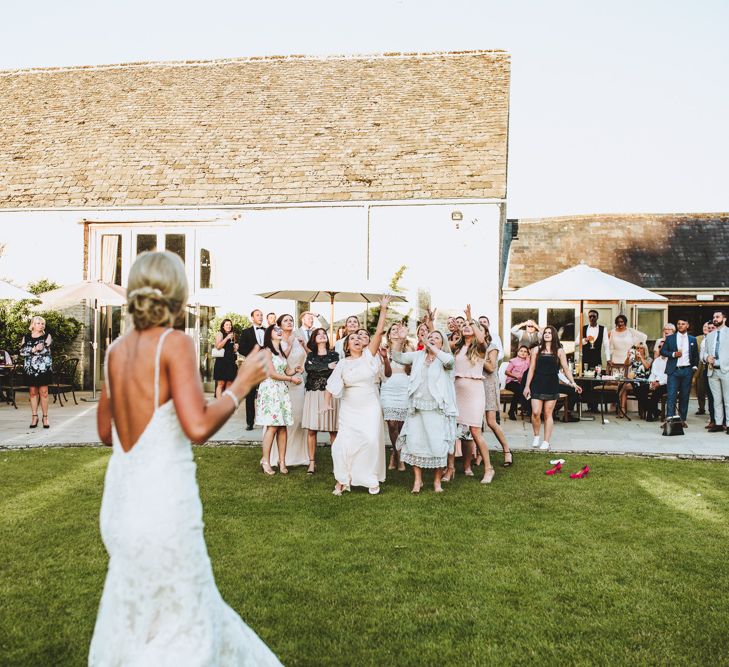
[{"left": 0, "top": 51, "right": 510, "bottom": 208}]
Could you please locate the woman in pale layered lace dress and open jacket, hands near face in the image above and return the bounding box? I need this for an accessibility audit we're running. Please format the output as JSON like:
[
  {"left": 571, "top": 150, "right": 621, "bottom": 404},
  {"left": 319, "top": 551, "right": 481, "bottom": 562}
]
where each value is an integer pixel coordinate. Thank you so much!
[{"left": 392, "top": 331, "right": 458, "bottom": 493}]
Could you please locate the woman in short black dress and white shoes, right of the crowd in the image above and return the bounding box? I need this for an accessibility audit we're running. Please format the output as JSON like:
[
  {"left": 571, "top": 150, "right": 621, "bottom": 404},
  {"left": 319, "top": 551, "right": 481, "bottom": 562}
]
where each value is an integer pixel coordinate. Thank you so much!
[{"left": 524, "top": 325, "right": 582, "bottom": 450}]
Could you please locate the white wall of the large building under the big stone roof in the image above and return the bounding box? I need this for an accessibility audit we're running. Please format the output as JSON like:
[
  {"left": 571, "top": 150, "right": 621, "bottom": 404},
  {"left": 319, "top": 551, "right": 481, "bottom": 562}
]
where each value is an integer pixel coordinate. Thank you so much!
[{"left": 0, "top": 202, "right": 500, "bottom": 328}]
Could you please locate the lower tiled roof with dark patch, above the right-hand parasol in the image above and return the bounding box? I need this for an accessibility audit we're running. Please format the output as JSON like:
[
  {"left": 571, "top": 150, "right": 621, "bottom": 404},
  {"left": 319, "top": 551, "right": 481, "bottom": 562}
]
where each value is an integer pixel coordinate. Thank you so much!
[{"left": 504, "top": 213, "right": 729, "bottom": 290}]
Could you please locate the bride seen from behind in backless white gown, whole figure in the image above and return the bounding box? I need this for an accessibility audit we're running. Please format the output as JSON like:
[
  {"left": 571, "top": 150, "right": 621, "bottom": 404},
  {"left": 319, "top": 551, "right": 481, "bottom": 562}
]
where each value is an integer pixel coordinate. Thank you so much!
[{"left": 88, "top": 252, "right": 280, "bottom": 667}]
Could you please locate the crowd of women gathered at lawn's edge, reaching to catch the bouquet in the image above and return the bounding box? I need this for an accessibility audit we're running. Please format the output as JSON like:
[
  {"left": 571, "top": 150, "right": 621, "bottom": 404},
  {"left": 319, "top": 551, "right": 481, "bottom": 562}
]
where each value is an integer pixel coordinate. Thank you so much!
[{"left": 232, "top": 297, "right": 592, "bottom": 495}]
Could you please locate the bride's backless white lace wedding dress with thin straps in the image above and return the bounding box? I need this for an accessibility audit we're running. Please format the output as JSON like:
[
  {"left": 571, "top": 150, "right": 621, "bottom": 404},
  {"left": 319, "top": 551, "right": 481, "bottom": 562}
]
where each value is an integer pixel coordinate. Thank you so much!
[{"left": 89, "top": 330, "right": 281, "bottom": 667}]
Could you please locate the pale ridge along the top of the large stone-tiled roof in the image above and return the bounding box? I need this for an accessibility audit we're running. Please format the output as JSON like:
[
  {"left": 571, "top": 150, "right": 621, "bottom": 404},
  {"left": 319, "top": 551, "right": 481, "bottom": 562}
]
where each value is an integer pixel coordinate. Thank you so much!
[{"left": 0, "top": 49, "right": 509, "bottom": 76}]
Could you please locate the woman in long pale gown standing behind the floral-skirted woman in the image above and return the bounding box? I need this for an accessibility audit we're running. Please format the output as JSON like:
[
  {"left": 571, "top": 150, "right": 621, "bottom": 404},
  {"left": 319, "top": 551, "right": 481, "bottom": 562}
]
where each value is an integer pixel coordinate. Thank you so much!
[{"left": 271, "top": 315, "right": 309, "bottom": 467}]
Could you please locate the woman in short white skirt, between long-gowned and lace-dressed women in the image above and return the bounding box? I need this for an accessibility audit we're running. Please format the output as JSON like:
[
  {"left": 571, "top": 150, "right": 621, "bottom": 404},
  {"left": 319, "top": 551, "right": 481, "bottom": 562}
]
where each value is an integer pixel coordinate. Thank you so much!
[{"left": 380, "top": 322, "right": 410, "bottom": 471}]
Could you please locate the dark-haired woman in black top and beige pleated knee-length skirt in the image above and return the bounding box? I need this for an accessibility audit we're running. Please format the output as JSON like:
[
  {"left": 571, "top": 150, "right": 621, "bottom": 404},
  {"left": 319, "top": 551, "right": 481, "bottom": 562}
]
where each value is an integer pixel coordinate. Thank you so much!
[{"left": 301, "top": 328, "right": 339, "bottom": 475}]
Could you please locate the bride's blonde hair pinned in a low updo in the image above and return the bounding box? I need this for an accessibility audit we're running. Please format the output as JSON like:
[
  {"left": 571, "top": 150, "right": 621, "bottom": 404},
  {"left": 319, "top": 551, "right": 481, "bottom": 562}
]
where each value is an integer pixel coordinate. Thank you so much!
[{"left": 127, "top": 251, "right": 187, "bottom": 330}]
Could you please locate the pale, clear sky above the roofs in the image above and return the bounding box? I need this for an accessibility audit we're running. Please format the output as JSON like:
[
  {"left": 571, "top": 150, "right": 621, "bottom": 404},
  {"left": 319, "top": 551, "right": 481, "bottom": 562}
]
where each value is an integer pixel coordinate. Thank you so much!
[{"left": 0, "top": 0, "right": 729, "bottom": 218}]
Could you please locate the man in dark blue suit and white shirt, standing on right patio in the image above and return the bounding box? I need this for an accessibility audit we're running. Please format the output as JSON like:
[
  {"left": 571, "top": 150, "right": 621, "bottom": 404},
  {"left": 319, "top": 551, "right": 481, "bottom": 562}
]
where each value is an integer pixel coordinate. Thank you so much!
[{"left": 661, "top": 320, "right": 699, "bottom": 428}]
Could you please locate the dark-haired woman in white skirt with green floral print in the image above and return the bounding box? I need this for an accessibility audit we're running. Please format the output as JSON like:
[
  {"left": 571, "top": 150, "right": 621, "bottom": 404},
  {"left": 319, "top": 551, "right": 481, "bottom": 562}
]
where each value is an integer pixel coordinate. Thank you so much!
[{"left": 256, "top": 324, "right": 301, "bottom": 475}]
